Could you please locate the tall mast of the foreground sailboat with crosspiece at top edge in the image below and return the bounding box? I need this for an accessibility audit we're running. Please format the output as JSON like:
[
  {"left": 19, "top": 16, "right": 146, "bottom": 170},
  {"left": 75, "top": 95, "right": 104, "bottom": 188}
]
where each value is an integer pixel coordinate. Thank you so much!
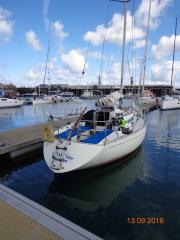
[{"left": 111, "top": 0, "right": 130, "bottom": 92}]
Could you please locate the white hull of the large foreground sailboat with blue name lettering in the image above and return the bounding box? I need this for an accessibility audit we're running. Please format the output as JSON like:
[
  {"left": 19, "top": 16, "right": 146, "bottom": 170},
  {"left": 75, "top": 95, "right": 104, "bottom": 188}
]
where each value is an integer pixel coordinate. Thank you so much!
[{"left": 44, "top": 119, "right": 146, "bottom": 173}]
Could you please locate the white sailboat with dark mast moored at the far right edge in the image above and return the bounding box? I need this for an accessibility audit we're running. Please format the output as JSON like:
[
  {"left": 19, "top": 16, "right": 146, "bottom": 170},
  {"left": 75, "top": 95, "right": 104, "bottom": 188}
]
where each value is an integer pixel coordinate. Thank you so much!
[{"left": 161, "top": 17, "right": 180, "bottom": 110}]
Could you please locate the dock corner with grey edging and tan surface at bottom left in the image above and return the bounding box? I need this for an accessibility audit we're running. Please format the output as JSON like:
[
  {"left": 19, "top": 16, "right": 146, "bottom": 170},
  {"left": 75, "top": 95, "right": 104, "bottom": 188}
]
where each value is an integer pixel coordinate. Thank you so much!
[{"left": 0, "top": 184, "right": 101, "bottom": 240}]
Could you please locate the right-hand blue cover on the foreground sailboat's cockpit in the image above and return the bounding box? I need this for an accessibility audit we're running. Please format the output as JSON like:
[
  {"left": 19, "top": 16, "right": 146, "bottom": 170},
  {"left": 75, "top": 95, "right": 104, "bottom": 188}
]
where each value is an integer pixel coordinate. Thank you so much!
[{"left": 80, "top": 129, "right": 113, "bottom": 144}]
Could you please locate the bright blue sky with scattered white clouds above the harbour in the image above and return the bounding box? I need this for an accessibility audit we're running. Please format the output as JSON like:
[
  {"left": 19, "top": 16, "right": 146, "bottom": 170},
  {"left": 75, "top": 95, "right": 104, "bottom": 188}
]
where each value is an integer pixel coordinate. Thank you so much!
[{"left": 0, "top": 0, "right": 180, "bottom": 87}]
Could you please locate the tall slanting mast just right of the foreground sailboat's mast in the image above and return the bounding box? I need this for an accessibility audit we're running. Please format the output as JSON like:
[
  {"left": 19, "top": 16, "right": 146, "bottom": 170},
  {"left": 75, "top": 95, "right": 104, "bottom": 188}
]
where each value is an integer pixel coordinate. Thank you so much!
[{"left": 141, "top": 0, "right": 151, "bottom": 96}]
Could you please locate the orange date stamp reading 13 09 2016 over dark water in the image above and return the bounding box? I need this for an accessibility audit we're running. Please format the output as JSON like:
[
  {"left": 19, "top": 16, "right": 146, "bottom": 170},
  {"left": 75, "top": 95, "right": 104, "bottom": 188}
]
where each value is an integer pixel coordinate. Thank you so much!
[{"left": 127, "top": 217, "right": 165, "bottom": 224}]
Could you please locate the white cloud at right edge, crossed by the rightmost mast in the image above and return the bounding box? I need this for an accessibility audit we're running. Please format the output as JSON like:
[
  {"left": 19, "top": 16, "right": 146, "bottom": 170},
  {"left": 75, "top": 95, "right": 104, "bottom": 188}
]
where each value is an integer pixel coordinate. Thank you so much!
[{"left": 152, "top": 35, "right": 180, "bottom": 59}]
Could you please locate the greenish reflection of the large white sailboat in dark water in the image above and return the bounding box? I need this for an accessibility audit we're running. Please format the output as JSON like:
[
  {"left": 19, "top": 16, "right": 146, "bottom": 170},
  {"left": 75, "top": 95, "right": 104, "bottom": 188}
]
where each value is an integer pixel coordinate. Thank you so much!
[{"left": 46, "top": 148, "right": 144, "bottom": 211}]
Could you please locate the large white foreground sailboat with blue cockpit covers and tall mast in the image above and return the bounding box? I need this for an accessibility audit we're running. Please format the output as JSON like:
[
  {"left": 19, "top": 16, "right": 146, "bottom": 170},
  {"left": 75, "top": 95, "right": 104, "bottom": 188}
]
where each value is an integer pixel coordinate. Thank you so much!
[{"left": 43, "top": 1, "right": 146, "bottom": 174}]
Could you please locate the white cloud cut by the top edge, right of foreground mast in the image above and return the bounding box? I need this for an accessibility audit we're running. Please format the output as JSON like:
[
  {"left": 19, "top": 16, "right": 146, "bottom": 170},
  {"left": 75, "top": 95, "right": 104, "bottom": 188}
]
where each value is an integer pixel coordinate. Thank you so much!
[{"left": 135, "top": 0, "right": 172, "bottom": 29}]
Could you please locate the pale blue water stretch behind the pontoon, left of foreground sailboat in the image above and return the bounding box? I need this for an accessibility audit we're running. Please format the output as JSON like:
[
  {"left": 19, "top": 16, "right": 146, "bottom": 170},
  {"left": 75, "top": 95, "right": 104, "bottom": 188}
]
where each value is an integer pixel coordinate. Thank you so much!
[{"left": 0, "top": 100, "right": 95, "bottom": 131}]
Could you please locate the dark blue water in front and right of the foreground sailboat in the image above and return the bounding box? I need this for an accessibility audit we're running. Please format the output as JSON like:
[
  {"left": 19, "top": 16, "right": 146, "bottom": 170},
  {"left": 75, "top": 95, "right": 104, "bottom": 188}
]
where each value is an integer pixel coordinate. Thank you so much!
[{"left": 0, "top": 110, "right": 180, "bottom": 240}]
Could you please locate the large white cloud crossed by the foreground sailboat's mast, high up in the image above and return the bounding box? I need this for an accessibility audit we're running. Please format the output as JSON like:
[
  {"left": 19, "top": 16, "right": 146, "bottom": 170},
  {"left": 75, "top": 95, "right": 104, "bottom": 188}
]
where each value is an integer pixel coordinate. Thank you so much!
[{"left": 84, "top": 11, "right": 145, "bottom": 45}]
